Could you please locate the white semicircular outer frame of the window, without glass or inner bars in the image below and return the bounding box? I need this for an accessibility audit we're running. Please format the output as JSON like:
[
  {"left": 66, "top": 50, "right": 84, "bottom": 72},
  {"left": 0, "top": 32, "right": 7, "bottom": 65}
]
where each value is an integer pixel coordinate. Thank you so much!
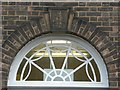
[{"left": 7, "top": 34, "right": 109, "bottom": 88}]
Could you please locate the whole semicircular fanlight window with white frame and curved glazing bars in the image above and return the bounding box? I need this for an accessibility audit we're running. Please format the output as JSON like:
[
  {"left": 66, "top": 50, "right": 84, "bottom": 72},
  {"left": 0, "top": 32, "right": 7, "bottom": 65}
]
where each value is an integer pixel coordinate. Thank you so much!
[{"left": 8, "top": 34, "right": 108, "bottom": 87}]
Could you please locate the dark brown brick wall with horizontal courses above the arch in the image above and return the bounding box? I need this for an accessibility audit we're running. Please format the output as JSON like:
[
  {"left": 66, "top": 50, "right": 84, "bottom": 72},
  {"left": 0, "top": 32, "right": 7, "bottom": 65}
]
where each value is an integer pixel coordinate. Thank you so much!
[{"left": 2, "top": 2, "right": 119, "bottom": 44}]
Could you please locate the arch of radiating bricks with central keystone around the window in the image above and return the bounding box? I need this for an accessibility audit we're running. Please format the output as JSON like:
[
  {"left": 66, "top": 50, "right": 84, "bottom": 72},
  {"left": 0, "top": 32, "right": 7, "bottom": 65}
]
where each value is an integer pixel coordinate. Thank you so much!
[{"left": 2, "top": 9, "right": 117, "bottom": 86}]
